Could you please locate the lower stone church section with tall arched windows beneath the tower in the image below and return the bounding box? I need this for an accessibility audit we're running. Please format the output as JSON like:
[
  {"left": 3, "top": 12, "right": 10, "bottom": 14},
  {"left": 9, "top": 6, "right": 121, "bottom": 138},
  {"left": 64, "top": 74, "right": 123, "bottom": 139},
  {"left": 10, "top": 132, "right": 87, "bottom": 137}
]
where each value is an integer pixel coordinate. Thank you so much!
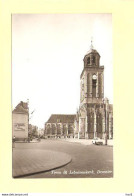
[{"left": 78, "top": 99, "right": 113, "bottom": 139}]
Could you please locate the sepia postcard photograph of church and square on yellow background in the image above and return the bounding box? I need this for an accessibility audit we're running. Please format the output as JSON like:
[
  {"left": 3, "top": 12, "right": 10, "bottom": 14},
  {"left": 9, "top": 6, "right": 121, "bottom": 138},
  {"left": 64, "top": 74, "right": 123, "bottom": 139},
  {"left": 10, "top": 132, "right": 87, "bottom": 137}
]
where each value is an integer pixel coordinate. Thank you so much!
[{"left": 11, "top": 13, "right": 114, "bottom": 179}]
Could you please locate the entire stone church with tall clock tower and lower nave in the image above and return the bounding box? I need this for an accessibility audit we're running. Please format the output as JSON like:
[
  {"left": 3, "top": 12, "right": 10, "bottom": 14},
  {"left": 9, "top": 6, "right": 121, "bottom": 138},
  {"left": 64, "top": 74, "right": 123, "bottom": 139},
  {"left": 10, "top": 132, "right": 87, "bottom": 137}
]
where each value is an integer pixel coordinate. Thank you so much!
[{"left": 45, "top": 44, "right": 113, "bottom": 139}]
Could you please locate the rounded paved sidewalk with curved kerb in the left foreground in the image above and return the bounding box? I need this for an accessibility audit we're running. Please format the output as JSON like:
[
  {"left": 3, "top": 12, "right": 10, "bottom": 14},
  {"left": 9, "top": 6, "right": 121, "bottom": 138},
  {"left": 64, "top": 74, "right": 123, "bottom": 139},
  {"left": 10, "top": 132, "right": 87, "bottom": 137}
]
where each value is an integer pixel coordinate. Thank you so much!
[{"left": 12, "top": 148, "right": 71, "bottom": 177}]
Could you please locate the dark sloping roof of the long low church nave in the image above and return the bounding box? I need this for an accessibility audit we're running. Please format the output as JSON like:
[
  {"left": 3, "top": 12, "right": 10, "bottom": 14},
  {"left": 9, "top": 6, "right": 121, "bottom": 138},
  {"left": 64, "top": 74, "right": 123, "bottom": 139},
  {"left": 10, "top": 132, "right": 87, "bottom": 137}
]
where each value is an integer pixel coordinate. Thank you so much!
[{"left": 47, "top": 114, "right": 76, "bottom": 123}]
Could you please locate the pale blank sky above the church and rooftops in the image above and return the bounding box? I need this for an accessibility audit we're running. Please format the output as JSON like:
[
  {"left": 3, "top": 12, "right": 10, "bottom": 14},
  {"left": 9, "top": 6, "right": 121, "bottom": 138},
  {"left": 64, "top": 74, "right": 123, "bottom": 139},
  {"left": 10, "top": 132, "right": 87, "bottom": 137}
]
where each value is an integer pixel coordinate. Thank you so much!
[{"left": 12, "top": 14, "right": 113, "bottom": 128}]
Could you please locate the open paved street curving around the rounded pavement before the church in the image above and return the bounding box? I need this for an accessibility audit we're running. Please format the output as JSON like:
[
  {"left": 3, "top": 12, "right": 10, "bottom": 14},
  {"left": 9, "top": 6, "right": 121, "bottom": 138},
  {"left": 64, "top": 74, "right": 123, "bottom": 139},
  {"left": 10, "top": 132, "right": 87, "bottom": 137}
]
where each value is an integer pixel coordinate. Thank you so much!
[{"left": 15, "top": 139, "right": 113, "bottom": 178}]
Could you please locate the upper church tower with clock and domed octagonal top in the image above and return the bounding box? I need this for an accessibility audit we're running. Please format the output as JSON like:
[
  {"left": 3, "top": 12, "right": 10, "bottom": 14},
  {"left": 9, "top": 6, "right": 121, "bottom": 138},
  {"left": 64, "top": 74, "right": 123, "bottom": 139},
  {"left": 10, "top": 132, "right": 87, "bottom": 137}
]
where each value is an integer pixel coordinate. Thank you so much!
[{"left": 80, "top": 41, "right": 104, "bottom": 106}]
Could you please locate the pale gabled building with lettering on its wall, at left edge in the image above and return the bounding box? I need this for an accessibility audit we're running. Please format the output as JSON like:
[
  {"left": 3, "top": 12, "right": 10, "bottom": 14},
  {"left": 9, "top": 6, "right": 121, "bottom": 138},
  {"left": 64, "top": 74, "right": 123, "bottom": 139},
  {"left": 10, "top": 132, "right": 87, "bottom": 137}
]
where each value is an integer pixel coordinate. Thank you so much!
[{"left": 12, "top": 101, "right": 29, "bottom": 140}]
